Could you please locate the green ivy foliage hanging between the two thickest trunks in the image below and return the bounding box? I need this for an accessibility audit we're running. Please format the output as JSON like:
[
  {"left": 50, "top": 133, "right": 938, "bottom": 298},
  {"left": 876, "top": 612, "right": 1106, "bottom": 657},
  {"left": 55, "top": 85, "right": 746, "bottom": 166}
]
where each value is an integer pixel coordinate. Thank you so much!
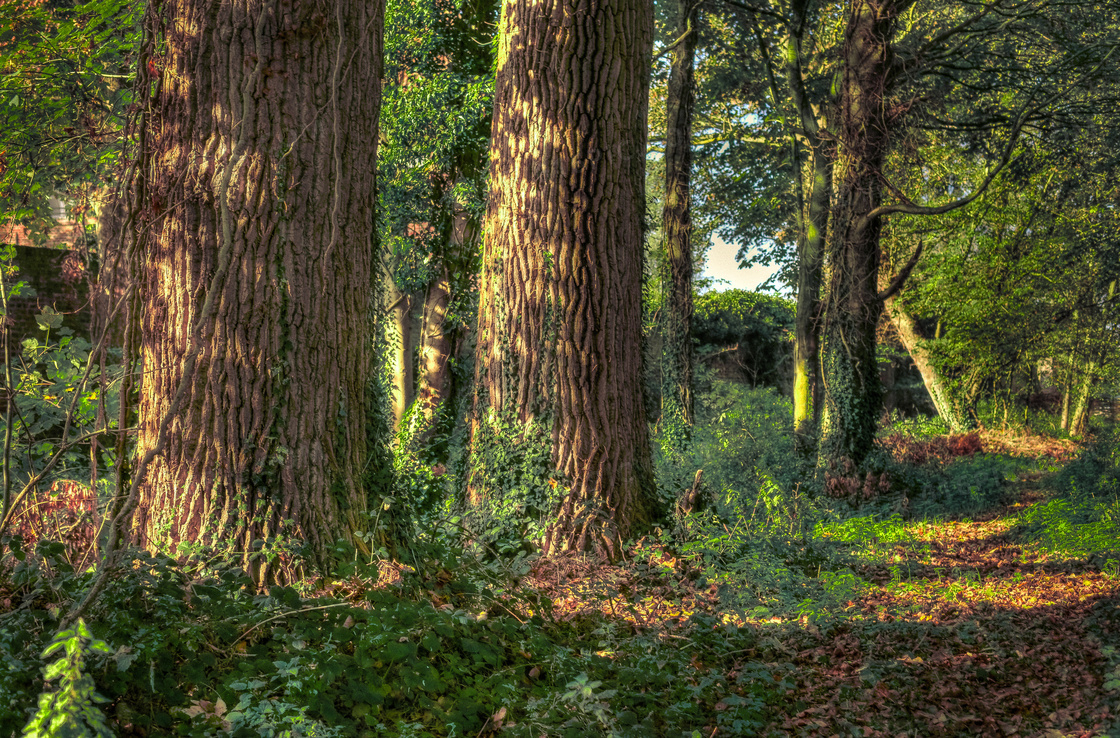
[{"left": 377, "top": 0, "right": 496, "bottom": 292}]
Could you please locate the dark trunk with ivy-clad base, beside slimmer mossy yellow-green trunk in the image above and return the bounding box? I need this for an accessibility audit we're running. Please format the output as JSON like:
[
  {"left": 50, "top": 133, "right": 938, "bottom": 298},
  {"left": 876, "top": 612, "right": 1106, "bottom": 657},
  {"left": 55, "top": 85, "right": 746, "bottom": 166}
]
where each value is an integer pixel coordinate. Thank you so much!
[{"left": 820, "top": 0, "right": 896, "bottom": 468}]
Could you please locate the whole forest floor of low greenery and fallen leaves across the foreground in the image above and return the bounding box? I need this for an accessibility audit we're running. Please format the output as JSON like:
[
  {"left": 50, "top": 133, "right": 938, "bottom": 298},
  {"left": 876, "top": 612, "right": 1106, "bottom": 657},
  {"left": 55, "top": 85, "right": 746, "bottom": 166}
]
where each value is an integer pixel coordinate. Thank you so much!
[{"left": 0, "top": 431, "right": 1120, "bottom": 738}]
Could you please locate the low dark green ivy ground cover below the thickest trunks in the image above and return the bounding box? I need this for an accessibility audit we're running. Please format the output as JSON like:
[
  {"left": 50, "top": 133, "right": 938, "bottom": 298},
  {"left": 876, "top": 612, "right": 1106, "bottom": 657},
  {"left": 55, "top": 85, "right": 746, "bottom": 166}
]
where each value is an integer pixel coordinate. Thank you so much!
[{"left": 0, "top": 542, "right": 791, "bottom": 738}]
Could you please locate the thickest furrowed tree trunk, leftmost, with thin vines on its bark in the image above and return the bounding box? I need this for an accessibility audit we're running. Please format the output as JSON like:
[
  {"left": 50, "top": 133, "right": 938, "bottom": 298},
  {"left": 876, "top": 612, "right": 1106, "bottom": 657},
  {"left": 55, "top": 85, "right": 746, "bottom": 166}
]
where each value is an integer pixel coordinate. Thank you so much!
[{"left": 134, "top": 0, "right": 392, "bottom": 580}]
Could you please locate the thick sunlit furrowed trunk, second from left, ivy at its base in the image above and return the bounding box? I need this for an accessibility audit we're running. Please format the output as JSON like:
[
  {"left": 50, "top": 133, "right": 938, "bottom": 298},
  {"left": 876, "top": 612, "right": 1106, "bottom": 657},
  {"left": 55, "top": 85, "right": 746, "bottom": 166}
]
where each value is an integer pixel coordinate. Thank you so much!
[{"left": 473, "top": 0, "right": 654, "bottom": 555}]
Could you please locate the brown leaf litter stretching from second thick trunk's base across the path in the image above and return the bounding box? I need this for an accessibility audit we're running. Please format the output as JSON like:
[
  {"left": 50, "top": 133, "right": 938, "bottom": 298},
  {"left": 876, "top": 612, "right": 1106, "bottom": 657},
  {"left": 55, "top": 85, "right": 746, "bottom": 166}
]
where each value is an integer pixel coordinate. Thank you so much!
[{"left": 521, "top": 473, "right": 1120, "bottom": 738}]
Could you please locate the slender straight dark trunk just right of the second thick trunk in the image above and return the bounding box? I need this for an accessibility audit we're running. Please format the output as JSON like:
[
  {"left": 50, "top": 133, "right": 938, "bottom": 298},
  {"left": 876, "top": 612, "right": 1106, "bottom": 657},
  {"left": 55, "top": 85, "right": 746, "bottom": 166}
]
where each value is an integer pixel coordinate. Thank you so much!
[{"left": 661, "top": 0, "right": 699, "bottom": 450}]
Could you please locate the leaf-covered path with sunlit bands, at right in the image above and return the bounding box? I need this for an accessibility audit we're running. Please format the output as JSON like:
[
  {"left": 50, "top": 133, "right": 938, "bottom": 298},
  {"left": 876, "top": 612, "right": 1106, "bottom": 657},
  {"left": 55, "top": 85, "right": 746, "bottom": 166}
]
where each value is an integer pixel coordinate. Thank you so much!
[{"left": 772, "top": 479, "right": 1120, "bottom": 736}]
